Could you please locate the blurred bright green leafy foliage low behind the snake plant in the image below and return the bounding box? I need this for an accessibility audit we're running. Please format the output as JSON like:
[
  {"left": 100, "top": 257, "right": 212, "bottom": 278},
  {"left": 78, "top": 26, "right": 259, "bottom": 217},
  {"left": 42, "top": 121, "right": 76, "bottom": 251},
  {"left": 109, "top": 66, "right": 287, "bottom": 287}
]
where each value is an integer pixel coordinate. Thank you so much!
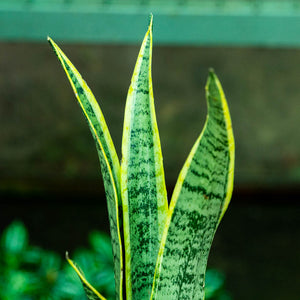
[{"left": 0, "top": 221, "right": 232, "bottom": 300}]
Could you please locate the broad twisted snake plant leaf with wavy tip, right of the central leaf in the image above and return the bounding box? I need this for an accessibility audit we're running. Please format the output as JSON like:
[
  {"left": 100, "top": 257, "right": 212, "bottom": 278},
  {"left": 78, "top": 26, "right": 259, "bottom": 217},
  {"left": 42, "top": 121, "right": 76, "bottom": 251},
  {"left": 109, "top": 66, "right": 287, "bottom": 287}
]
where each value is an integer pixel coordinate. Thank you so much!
[{"left": 151, "top": 71, "right": 234, "bottom": 300}]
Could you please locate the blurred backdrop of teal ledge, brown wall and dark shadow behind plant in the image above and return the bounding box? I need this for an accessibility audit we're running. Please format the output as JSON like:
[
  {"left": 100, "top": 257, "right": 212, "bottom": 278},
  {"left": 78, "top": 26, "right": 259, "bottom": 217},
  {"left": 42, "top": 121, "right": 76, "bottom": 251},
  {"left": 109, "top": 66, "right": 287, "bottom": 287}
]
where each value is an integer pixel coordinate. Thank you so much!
[{"left": 0, "top": 0, "right": 300, "bottom": 300}]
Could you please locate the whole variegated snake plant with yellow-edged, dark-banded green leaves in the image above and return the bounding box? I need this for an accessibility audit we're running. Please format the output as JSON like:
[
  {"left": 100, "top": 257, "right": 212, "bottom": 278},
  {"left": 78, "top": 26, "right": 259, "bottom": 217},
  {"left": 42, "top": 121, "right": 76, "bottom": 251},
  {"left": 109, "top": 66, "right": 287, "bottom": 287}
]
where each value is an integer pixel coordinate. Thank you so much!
[{"left": 48, "top": 16, "right": 234, "bottom": 300}]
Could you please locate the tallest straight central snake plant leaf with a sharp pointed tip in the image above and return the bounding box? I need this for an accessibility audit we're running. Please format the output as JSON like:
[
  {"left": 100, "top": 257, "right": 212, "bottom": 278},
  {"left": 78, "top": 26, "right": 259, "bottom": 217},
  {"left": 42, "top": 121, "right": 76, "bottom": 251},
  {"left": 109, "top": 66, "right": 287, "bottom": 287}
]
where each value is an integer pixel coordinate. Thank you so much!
[{"left": 121, "top": 17, "right": 168, "bottom": 300}]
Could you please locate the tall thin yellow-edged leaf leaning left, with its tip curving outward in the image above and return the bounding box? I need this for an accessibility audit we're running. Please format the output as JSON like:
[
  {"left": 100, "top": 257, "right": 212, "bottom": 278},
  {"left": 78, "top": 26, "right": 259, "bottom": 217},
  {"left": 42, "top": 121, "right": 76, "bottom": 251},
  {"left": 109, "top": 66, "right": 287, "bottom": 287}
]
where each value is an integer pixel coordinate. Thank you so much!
[{"left": 48, "top": 38, "right": 123, "bottom": 299}]
